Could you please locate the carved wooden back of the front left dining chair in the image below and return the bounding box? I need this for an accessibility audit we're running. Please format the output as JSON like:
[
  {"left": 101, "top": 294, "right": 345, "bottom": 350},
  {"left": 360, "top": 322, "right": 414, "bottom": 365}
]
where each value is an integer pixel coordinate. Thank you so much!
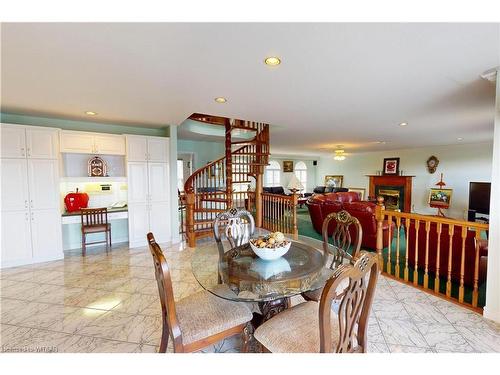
[{"left": 147, "top": 233, "right": 182, "bottom": 352}]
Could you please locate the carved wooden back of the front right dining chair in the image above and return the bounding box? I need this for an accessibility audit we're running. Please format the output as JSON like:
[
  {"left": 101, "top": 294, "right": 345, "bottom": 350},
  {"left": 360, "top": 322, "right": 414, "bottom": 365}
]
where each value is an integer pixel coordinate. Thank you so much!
[{"left": 319, "top": 251, "right": 379, "bottom": 353}]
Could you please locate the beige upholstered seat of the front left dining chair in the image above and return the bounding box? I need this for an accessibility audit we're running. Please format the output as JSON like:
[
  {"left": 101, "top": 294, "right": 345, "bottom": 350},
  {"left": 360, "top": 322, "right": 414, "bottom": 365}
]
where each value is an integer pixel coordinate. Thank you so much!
[{"left": 175, "top": 286, "right": 252, "bottom": 345}]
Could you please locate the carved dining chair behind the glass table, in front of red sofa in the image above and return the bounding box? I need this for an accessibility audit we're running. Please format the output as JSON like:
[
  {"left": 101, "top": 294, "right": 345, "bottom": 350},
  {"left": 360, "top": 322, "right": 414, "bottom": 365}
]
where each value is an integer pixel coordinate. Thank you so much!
[{"left": 302, "top": 211, "right": 363, "bottom": 301}]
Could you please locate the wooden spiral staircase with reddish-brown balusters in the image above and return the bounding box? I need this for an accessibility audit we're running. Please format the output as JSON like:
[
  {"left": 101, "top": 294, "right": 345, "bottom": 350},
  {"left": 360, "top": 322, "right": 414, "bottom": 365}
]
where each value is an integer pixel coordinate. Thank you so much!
[{"left": 184, "top": 114, "right": 269, "bottom": 247}]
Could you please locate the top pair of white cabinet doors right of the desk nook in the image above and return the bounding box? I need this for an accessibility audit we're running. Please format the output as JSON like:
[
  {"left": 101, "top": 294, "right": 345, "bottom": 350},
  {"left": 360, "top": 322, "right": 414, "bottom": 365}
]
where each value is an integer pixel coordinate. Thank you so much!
[{"left": 127, "top": 135, "right": 169, "bottom": 162}]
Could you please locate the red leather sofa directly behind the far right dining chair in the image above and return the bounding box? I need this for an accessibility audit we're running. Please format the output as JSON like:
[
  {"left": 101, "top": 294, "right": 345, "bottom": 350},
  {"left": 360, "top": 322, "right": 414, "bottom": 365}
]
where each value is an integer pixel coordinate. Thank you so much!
[{"left": 306, "top": 192, "right": 394, "bottom": 250}]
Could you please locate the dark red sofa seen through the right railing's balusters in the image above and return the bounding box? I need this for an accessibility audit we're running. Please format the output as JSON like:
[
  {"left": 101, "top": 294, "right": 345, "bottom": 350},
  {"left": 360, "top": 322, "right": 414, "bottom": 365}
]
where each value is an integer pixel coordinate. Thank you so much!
[{"left": 406, "top": 220, "right": 488, "bottom": 286}]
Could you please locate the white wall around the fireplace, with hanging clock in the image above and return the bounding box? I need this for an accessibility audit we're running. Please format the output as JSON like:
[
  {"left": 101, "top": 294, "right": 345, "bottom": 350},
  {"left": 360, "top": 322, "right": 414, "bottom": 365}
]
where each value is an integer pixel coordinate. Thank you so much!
[{"left": 316, "top": 143, "right": 493, "bottom": 219}]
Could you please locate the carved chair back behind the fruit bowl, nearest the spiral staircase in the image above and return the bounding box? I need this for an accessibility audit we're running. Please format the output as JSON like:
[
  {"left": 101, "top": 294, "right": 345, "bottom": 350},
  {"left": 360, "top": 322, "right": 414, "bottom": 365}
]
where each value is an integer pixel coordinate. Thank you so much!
[{"left": 214, "top": 208, "right": 255, "bottom": 254}]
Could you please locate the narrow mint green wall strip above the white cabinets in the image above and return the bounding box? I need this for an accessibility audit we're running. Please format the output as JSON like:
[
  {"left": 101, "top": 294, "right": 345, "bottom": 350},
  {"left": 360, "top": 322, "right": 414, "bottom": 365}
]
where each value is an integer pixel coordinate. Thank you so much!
[{"left": 0, "top": 112, "right": 169, "bottom": 137}]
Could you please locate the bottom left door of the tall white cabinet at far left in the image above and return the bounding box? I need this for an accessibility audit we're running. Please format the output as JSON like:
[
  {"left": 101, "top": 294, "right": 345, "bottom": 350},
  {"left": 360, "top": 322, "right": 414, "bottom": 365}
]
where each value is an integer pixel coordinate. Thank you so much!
[{"left": 1, "top": 210, "right": 32, "bottom": 267}]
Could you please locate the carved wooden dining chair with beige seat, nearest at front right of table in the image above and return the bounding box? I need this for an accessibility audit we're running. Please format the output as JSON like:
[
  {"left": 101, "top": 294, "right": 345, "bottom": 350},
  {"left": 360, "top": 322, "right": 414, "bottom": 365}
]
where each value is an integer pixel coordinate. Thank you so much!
[{"left": 254, "top": 251, "right": 379, "bottom": 353}]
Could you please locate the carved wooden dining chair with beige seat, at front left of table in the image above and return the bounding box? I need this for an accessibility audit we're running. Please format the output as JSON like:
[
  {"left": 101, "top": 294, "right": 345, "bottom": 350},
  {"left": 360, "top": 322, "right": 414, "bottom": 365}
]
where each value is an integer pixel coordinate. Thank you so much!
[{"left": 147, "top": 233, "right": 253, "bottom": 353}]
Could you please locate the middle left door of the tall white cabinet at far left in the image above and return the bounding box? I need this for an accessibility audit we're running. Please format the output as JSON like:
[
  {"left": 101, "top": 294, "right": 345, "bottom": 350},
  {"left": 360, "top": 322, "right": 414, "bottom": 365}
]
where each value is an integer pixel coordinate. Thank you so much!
[{"left": 1, "top": 159, "right": 29, "bottom": 211}]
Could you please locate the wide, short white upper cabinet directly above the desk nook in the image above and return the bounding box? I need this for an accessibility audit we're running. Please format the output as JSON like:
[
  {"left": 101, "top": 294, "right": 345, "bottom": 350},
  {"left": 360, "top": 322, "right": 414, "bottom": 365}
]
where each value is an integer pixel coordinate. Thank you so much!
[{"left": 61, "top": 130, "right": 125, "bottom": 155}]
